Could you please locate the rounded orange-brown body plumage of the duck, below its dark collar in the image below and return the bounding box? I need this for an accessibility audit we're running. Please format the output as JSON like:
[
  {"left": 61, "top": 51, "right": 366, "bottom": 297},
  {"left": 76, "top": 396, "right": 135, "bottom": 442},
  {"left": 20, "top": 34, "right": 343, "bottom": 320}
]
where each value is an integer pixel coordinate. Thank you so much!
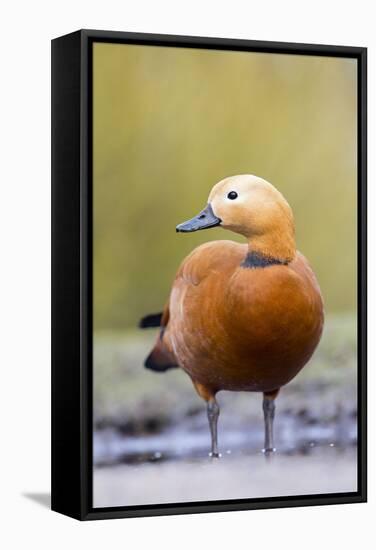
[{"left": 163, "top": 241, "right": 322, "bottom": 393}]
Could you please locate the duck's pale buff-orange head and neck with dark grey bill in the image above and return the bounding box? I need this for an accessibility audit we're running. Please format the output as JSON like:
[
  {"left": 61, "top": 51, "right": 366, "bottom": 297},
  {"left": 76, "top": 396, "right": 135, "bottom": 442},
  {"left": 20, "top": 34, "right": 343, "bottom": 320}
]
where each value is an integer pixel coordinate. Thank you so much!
[{"left": 176, "top": 175, "right": 296, "bottom": 262}]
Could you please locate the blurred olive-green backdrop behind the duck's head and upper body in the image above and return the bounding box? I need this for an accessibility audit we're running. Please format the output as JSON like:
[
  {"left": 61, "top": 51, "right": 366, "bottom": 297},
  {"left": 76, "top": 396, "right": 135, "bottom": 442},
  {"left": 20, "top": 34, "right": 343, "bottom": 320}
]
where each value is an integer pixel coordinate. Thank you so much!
[{"left": 93, "top": 43, "right": 357, "bottom": 331}]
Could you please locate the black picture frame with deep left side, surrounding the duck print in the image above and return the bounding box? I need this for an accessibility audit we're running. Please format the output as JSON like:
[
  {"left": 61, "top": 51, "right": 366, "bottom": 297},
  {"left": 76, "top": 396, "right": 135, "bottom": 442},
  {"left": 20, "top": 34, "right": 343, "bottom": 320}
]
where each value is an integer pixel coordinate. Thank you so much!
[{"left": 52, "top": 30, "right": 367, "bottom": 520}]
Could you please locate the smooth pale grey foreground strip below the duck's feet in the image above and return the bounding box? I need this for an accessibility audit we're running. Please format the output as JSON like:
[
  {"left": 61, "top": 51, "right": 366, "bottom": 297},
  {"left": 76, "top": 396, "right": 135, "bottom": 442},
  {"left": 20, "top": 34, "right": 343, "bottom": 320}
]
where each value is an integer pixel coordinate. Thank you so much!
[{"left": 94, "top": 447, "right": 357, "bottom": 507}]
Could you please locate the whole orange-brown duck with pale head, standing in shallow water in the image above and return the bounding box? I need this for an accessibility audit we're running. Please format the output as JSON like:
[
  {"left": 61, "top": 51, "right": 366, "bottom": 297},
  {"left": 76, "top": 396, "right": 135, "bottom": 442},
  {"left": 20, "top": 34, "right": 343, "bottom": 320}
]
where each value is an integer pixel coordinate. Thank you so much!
[{"left": 140, "top": 175, "right": 324, "bottom": 457}]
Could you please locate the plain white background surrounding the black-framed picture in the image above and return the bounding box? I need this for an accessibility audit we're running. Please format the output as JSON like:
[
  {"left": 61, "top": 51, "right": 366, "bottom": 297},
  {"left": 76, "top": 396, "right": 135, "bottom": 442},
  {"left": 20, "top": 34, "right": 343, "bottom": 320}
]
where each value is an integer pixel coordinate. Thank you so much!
[{"left": 0, "top": 0, "right": 376, "bottom": 550}]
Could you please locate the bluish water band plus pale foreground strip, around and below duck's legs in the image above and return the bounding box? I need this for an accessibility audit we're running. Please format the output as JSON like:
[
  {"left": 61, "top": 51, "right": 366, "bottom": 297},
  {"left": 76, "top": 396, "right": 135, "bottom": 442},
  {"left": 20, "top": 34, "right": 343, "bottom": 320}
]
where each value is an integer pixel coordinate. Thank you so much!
[{"left": 93, "top": 406, "right": 357, "bottom": 507}]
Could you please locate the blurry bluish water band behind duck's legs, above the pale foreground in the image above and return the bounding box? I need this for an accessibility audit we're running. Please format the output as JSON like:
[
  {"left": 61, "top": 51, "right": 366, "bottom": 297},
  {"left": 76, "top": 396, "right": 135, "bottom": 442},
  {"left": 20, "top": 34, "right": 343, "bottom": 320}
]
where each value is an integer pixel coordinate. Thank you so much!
[{"left": 94, "top": 409, "right": 357, "bottom": 466}]
